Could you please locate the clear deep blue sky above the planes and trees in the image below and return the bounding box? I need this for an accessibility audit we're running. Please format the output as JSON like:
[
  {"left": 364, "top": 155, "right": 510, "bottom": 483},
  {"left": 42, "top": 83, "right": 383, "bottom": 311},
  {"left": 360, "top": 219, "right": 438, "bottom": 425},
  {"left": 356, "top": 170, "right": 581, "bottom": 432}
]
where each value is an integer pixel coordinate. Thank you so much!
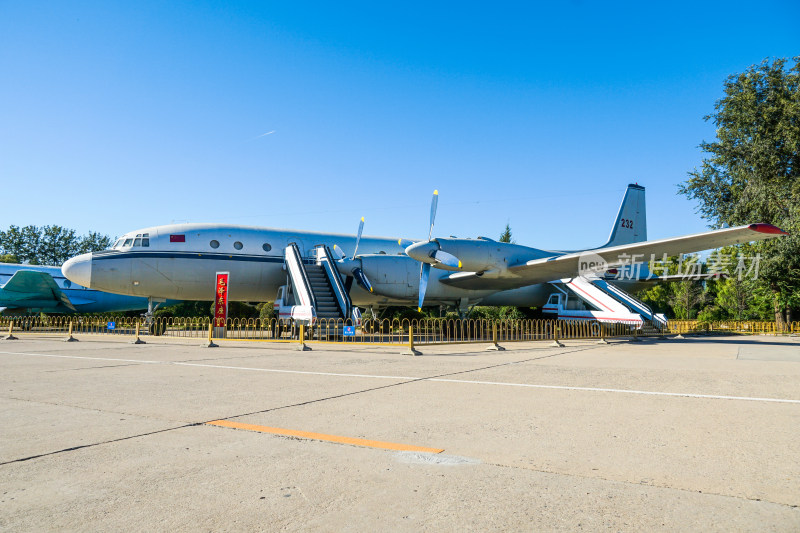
[{"left": 0, "top": 0, "right": 800, "bottom": 249}]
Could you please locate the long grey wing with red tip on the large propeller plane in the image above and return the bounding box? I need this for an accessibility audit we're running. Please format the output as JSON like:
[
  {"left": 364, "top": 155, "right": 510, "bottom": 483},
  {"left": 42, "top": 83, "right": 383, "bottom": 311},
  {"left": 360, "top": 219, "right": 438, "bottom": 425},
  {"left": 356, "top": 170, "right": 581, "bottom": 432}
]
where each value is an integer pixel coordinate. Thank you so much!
[{"left": 439, "top": 224, "right": 788, "bottom": 290}]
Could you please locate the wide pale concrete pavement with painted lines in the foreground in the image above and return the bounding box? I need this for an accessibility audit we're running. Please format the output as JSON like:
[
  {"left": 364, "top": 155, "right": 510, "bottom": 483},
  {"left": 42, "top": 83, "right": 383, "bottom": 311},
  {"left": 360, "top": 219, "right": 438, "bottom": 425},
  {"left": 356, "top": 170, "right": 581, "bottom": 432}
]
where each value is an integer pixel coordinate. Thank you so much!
[{"left": 0, "top": 336, "right": 800, "bottom": 531}]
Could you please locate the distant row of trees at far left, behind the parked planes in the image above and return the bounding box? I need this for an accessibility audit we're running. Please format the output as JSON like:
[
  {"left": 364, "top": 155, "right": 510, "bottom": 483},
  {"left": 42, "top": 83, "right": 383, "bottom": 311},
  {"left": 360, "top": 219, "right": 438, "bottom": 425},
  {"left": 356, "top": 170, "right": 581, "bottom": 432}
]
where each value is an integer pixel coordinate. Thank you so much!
[{"left": 0, "top": 225, "right": 111, "bottom": 265}]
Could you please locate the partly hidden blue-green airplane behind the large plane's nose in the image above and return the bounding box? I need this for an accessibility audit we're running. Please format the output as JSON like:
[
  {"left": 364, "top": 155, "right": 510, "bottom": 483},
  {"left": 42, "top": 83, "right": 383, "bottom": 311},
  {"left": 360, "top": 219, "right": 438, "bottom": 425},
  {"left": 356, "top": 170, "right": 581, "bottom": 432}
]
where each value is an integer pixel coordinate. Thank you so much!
[{"left": 0, "top": 263, "right": 178, "bottom": 314}]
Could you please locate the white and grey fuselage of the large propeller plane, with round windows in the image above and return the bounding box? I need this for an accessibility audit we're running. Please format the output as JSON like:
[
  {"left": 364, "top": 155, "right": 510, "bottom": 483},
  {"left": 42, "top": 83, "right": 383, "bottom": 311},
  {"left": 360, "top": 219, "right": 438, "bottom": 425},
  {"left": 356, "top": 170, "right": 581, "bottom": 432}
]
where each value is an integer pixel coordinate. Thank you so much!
[{"left": 63, "top": 224, "right": 551, "bottom": 306}]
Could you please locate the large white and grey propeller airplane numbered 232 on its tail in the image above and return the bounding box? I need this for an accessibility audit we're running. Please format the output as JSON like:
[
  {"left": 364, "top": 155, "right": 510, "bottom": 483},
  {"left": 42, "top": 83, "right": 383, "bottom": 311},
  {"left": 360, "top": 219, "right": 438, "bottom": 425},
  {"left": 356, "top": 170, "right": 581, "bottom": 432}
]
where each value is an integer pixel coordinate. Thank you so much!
[{"left": 62, "top": 184, "right": 787, "bottom": 317}]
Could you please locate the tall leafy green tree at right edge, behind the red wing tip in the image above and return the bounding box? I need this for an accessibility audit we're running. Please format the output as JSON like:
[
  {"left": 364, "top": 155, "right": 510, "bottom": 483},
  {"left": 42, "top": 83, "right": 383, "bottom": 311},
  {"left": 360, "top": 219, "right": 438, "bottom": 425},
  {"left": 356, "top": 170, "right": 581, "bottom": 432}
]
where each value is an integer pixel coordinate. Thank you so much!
[{"left": 680, "top": 56, "right": 800, "bottom": 327}]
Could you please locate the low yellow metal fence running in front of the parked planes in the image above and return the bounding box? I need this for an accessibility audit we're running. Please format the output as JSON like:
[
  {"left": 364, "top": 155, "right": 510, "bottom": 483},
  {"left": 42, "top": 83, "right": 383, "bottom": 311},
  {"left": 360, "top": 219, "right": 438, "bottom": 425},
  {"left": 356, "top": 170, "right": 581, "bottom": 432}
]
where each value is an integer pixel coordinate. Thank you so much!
[{"left": 0, "top": 315, "right": 800, "bottom": 351}]
